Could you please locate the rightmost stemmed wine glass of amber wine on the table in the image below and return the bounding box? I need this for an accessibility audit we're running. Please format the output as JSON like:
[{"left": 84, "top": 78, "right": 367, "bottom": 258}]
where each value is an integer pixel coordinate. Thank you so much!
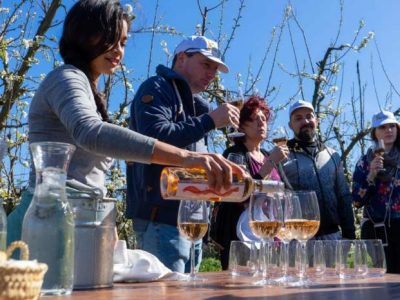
[{"left": 284, "top": 191, "right": 320, "bottom": 287}]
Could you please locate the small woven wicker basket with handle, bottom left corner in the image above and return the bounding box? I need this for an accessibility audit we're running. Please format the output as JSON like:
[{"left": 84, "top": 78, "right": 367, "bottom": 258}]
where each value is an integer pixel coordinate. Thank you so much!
[{"left": 0, "top": 241, "right": 47, "bottom": 300}]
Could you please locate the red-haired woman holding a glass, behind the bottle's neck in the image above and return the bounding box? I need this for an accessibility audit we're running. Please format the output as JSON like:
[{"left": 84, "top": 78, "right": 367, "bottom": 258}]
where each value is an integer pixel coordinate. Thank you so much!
[{"left": 211, "top": 96, "right": 289, "bottom": 270}]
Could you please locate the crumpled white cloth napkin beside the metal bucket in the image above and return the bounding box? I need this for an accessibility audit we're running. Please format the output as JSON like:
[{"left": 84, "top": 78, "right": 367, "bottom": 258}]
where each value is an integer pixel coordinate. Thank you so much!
[{"left": 113, "top": 240, "right": 188, "bottom": 282}]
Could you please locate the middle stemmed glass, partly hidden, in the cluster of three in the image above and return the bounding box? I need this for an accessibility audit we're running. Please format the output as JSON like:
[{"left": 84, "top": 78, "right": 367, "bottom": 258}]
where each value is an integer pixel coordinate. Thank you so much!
[{"left": 275, "top": 190, "right": 301, "bottom": 285}]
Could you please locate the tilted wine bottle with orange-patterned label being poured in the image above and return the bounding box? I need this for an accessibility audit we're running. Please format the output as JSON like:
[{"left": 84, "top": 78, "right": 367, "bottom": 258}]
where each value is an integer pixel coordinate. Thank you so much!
[{"left": 160, "top": 167, "right": 284, "bottom": 202}]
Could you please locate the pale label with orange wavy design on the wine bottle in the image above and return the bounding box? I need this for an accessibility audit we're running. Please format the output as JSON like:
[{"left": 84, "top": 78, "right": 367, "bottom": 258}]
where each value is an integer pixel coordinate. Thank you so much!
[{"left": 174, "top": 182, "right": 244, "bottom": 202}]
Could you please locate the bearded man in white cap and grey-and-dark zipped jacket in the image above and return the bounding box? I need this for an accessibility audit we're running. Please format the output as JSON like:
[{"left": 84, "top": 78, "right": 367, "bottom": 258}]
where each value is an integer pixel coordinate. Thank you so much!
[{"left": 284, "top": 100, "right": 355, "bottom": 240}]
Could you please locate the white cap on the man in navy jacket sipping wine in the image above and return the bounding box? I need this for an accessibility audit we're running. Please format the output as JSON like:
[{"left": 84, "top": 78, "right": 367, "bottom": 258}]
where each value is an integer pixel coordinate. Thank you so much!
[{"left": 174, "top": 35, "right": 229, "bottom": 73}]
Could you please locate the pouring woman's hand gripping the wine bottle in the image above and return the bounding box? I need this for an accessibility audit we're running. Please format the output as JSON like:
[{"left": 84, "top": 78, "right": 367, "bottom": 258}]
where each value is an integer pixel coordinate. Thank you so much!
[{"left": 183, "top": 151, "right": 248, "bottom": 191}]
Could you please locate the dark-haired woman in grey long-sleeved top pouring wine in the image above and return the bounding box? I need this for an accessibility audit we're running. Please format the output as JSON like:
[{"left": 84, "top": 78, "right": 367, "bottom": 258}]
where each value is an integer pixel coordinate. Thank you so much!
[{"left": 8, "top": 0, "right": 242, "bottom": 243}]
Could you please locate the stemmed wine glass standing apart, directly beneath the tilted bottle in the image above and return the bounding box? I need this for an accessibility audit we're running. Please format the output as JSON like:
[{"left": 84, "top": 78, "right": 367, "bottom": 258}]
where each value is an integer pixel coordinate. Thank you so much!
[{"left": 178, "top": 200, "right": 208, "bottom": 281}]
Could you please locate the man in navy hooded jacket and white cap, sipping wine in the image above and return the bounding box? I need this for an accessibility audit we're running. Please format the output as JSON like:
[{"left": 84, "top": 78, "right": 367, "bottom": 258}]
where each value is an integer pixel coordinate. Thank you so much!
[{"left": 127, "top": 36, "right": 239, "bottom": 272}]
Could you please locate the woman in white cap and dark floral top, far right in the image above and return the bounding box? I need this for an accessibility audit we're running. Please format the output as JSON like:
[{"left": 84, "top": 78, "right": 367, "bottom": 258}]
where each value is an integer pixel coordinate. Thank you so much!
[{"left": 352, "top": 111, "right": 400, "bottom": 273}]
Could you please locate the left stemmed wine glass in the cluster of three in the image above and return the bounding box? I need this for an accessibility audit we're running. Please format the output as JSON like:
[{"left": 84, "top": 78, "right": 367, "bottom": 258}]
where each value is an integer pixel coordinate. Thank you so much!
[{"left": 249, "top": 192, "right": 283, "bottom": 285}]
